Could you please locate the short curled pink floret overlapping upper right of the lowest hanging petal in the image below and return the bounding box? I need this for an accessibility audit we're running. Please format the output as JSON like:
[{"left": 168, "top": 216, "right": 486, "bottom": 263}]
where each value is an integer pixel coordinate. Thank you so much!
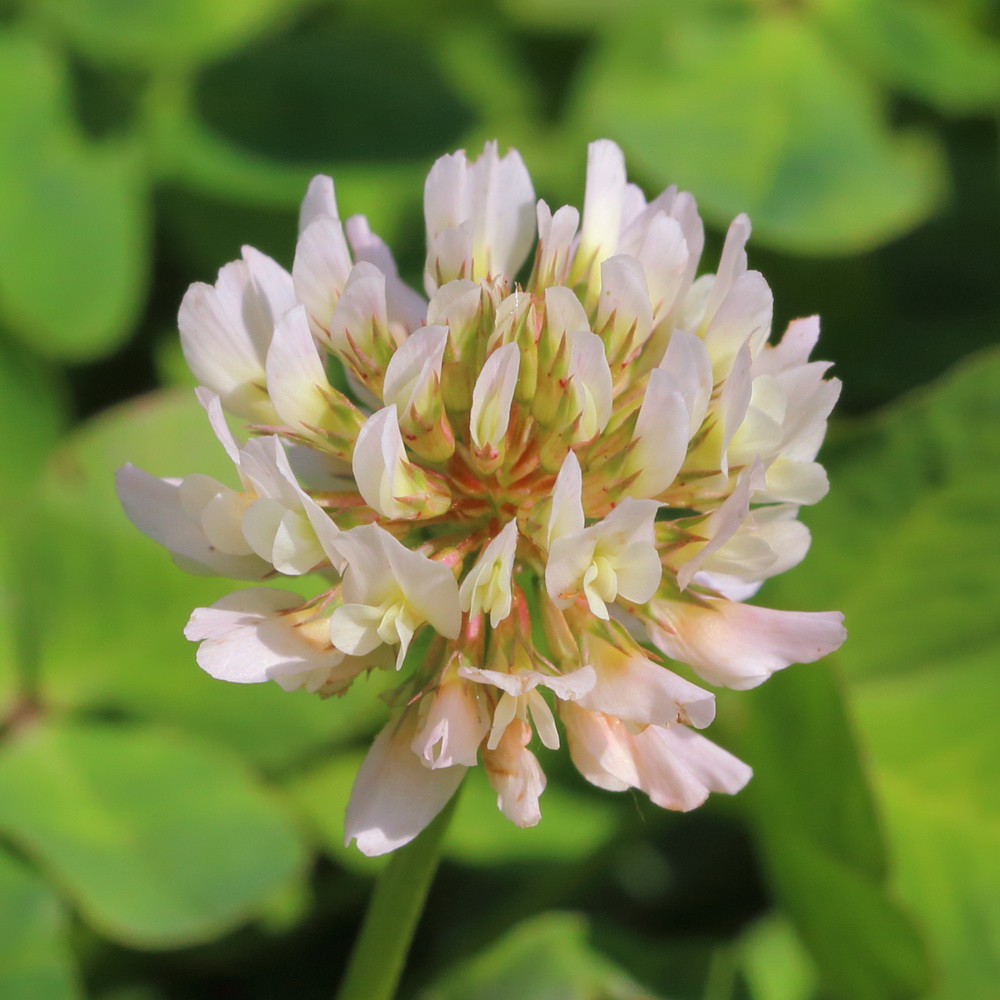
[{"left": 411, "top": 676, "right": 490, "bottom": 768}]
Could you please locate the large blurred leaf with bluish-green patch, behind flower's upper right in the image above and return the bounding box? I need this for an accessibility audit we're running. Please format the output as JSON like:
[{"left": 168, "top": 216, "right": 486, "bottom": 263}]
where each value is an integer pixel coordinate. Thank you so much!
[{"left": 576, "top": 2, "right": 943, "bottom": 253}]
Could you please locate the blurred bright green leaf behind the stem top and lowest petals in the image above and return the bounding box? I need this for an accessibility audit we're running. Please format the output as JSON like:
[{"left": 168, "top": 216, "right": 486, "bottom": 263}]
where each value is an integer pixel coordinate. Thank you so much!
[{"left": 289, "top": 752, "right": 617, "bottom": 874}]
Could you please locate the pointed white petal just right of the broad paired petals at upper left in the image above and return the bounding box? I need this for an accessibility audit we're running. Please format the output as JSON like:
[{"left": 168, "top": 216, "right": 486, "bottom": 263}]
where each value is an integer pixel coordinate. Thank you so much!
[{"left": 266, "top": 306, "right": 340, "bottom": 432}]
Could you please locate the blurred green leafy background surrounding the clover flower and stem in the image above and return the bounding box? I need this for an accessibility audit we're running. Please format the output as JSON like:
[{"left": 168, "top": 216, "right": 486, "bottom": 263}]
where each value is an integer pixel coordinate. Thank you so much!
[{"left": 0, "top": 0, "right": 1000, "bottom": 1000}]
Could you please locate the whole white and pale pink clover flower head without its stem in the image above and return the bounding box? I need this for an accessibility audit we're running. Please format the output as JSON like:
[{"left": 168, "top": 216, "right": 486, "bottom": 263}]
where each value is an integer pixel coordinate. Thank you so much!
[{"left": 118, "top": 141, "right": 845, "bottom": 855}]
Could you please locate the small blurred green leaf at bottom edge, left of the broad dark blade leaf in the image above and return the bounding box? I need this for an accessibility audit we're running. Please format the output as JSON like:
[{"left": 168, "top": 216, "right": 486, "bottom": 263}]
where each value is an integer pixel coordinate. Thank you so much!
[{"left": 739, "top": 916, "right": 817, "bottom": 1000}]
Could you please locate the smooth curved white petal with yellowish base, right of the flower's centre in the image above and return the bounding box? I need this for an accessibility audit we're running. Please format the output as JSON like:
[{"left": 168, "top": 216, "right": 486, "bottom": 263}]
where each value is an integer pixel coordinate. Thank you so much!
[{"left": 626, "top": 368, "right": 691, "bottom": 498}]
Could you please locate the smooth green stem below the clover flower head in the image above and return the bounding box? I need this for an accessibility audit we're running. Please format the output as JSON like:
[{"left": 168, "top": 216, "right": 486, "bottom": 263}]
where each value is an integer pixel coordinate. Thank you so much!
[{"left": 337, "top": 792, "right": 459, "bottom": 1000}]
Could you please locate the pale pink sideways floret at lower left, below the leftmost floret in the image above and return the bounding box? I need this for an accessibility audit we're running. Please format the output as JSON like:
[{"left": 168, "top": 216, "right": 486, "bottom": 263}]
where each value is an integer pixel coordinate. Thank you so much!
[{"left": 184, "top": 587, "right": 336, "bottom": 684}]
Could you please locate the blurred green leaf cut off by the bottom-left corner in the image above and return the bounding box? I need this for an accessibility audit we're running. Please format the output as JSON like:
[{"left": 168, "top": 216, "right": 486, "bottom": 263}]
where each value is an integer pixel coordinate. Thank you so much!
[{"left": 0, "top": 852, "right": 83, "bottom": 1000}]
